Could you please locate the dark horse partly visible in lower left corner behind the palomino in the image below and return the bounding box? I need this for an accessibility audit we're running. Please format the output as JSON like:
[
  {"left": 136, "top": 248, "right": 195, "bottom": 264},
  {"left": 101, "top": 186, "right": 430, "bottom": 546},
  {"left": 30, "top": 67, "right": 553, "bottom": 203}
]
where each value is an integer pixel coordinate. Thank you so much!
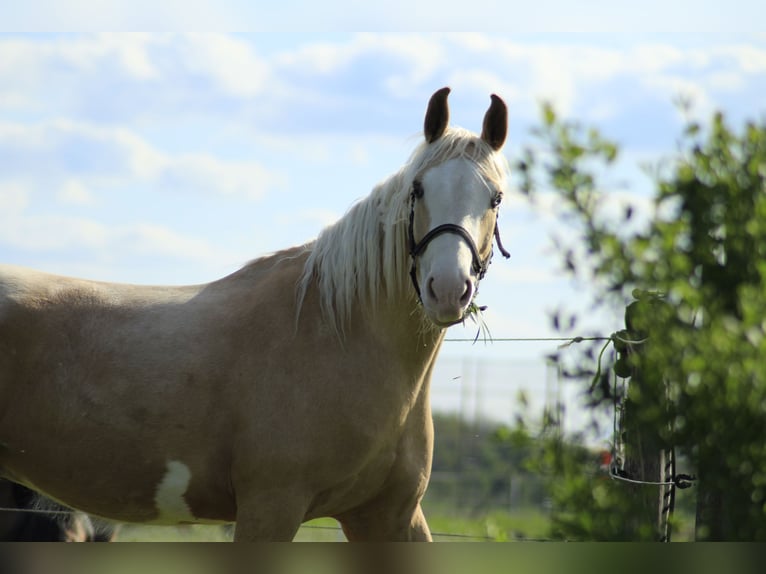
[{"left": 0, "top": 479, "right": 117, "bottom": 542}]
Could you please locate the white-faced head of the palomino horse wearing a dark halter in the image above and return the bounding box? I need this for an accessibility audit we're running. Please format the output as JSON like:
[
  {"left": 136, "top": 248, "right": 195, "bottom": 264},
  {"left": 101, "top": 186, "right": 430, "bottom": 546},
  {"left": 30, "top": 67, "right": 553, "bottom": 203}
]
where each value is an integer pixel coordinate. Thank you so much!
[{"left": 409, "top": 88, "right": 508, "bottom": 327}]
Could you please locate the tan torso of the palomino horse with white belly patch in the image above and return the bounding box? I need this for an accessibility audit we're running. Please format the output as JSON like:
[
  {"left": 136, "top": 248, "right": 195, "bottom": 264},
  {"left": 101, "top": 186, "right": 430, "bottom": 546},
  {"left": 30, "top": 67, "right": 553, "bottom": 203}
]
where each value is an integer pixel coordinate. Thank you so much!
[{"left": 0, "top": 250, "right": 438, "bottom": 537}]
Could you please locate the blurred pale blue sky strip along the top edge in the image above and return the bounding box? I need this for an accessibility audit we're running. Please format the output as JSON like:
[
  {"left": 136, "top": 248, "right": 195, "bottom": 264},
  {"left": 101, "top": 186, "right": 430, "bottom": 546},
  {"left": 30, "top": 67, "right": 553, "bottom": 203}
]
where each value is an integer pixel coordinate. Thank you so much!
[{"left": 0, "top": 0, "right": 763, "bottom": 35}]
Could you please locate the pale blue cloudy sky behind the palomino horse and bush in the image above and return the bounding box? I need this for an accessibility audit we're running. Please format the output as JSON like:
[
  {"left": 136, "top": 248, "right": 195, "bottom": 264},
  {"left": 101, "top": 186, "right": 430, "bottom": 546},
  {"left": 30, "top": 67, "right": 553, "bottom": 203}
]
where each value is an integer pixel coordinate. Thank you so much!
[{"left": 0, "top": 28, "right": 766, "bottom": 432}]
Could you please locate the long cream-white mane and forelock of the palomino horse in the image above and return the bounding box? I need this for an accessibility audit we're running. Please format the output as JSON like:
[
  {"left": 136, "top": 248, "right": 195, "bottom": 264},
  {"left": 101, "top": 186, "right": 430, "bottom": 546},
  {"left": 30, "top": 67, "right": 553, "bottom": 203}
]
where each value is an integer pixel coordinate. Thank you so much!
[{"left": 298, "top": 127, "right": 508, "bottom": 333}]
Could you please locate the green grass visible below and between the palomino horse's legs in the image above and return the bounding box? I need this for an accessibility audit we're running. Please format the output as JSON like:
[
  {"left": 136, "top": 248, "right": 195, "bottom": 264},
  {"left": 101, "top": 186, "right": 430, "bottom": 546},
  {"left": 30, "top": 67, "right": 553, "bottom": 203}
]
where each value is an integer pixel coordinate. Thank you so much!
[{"left": 118, "top": 509, "right": 548, "bottom": 542}]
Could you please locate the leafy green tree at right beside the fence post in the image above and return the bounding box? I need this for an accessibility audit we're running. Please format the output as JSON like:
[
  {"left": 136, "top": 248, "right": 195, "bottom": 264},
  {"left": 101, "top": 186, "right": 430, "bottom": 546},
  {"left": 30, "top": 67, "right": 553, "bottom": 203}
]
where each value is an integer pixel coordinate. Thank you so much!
[{"left": 517, "top": 107, "right": 766, "bottom": 540}]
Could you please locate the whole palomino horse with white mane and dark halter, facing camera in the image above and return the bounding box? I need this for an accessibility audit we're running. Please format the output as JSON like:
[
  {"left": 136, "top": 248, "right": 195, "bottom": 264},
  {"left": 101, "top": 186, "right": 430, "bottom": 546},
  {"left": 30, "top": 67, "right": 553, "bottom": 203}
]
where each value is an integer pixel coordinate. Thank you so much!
[{"left": 0, "top": 88, "right": 508, "bottom": 540}]
